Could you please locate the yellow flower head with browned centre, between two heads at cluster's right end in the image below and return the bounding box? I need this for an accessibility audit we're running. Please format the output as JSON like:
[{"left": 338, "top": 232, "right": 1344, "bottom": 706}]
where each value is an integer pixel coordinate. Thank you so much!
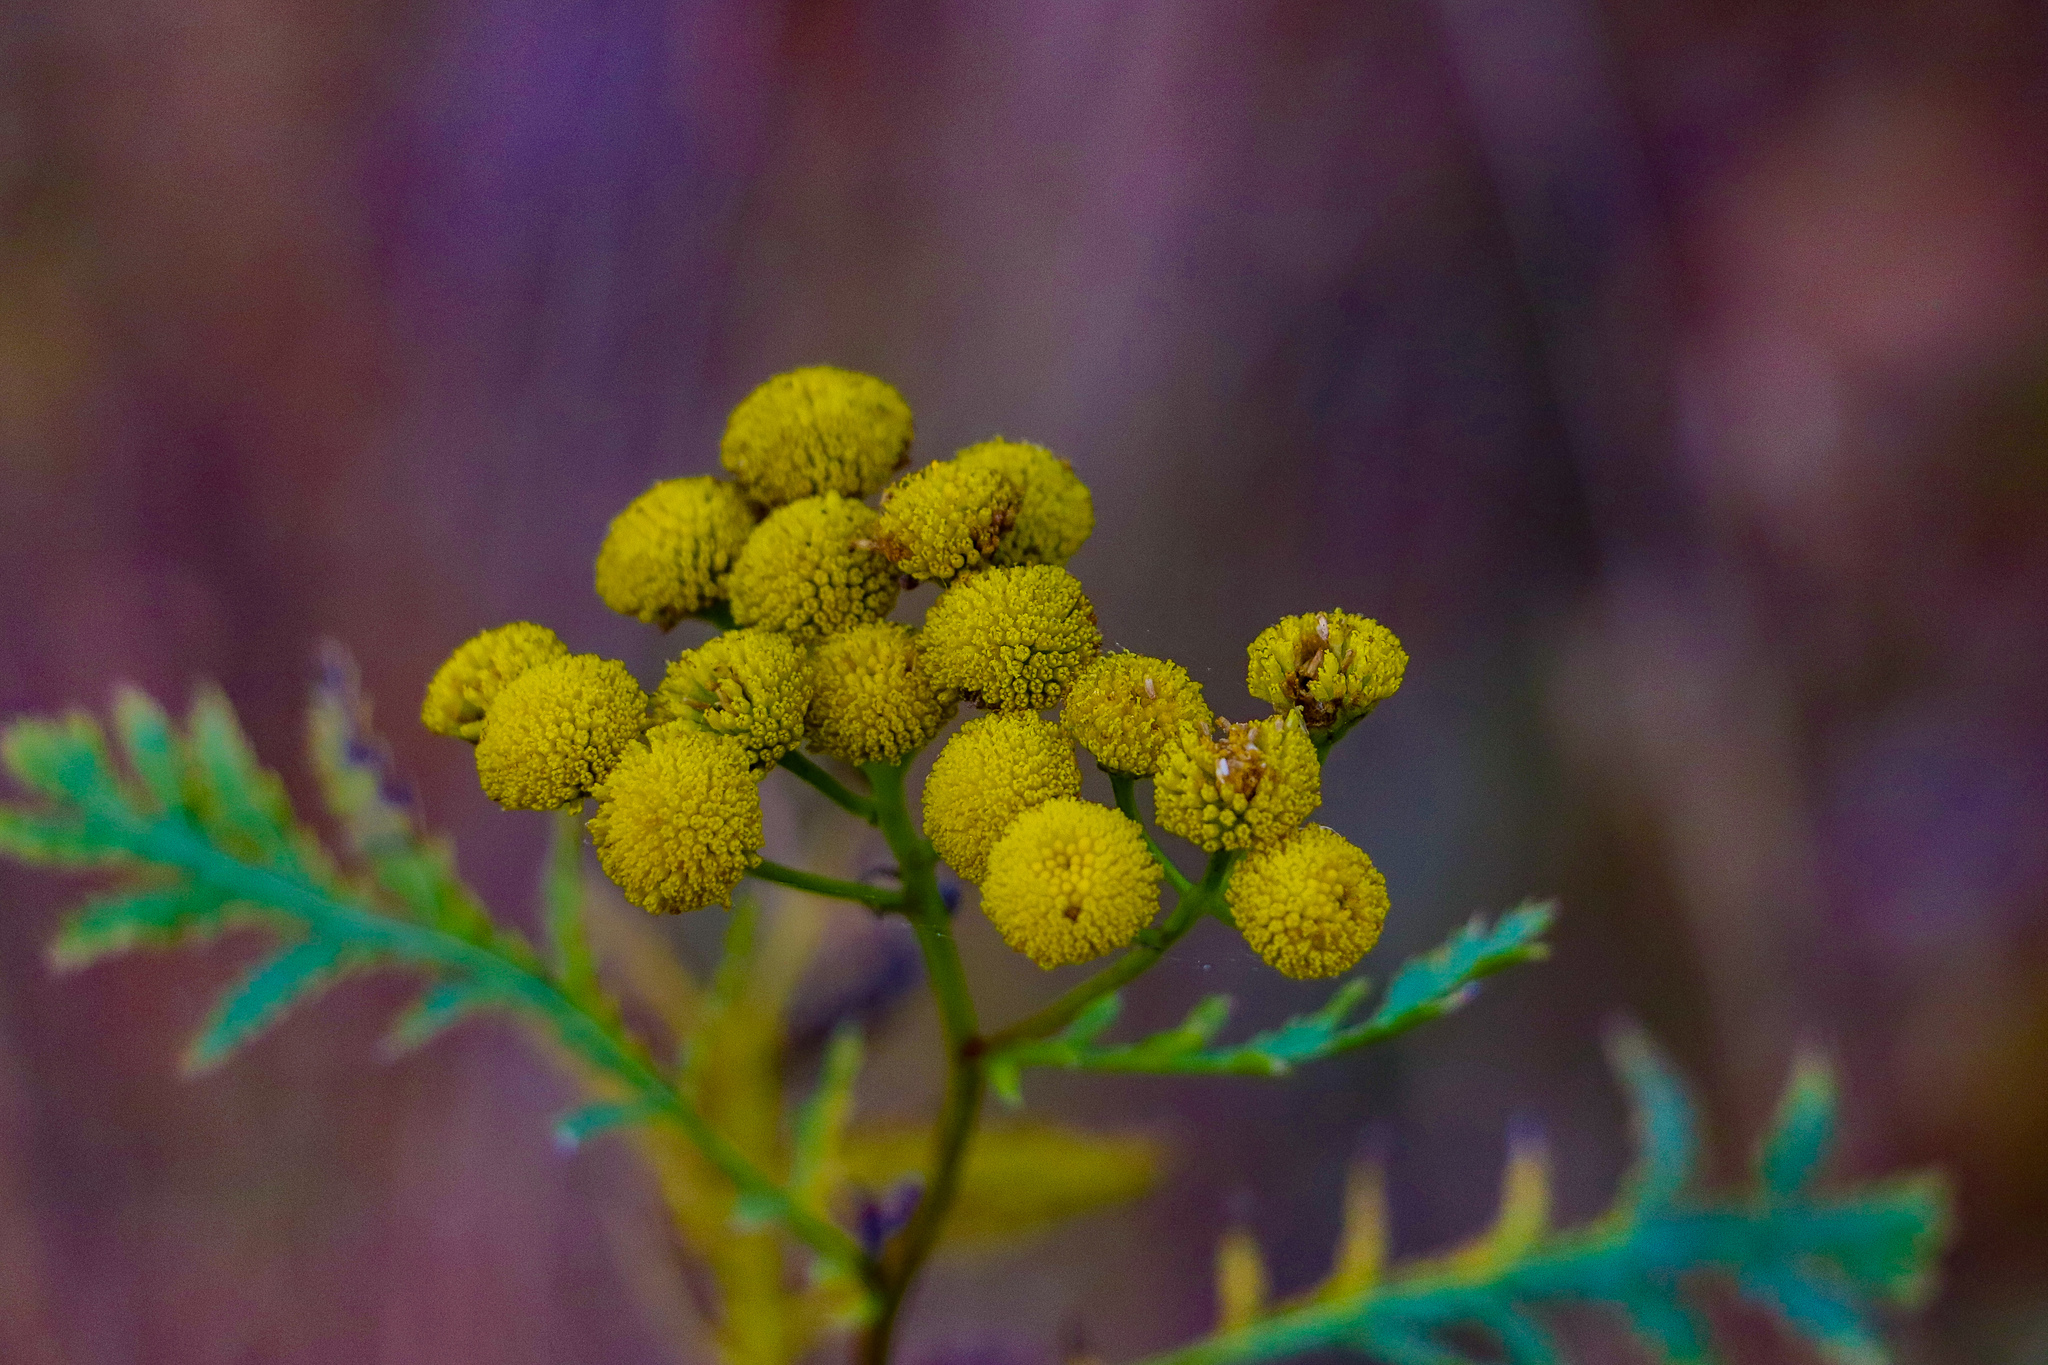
[{"left": 1153, "top": 712, "right": 1323, "bottom": 853}]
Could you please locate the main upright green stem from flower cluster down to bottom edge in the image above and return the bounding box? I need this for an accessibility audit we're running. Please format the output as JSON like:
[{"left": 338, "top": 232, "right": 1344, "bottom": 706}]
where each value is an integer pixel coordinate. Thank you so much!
[{"left": 860, "top": 763, "right": 987, "bottom": 1365}]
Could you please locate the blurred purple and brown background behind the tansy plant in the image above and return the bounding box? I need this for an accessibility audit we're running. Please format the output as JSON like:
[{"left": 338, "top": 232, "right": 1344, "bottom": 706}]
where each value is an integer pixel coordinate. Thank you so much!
[{"left": 0, "top": 0, "right": 2048, "bottom": 1365}]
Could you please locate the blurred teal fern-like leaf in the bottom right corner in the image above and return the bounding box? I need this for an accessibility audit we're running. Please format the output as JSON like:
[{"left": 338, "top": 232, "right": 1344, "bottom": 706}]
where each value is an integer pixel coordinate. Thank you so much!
[{"left": 1145, "top": 1033, "right": 1948, "bottom": 1365}]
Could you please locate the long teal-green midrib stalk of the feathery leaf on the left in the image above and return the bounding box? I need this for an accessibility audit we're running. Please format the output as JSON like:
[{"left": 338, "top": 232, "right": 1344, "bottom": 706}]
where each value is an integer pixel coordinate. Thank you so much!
[{"left": 86, "top": 785, "right": 881, "bottom": 1291}]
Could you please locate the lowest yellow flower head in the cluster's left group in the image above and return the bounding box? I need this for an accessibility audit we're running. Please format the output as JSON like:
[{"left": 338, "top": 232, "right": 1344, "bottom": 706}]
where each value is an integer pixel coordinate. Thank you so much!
[{"left": 590, "top": 724, "right": 762, "bottom": 915}]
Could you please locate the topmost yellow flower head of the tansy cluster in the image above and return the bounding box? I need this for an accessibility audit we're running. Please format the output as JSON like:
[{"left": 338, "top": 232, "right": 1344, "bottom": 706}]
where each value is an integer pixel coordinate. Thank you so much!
[{"left": 719, "top": 364, "right": 911, "bottom": 508}]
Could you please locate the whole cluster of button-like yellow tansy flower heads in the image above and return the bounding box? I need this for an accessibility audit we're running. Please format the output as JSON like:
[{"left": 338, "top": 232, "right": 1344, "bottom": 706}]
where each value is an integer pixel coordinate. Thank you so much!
[{"left": 420, "top": 366, "right": 1407, "bottom": 976}]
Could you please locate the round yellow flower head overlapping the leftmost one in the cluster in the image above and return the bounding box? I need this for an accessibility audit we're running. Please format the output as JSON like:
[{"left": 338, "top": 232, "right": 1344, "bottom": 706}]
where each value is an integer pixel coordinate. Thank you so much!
[{"left": 477, "top": 655, "right": 647, "bottom": 810}]
